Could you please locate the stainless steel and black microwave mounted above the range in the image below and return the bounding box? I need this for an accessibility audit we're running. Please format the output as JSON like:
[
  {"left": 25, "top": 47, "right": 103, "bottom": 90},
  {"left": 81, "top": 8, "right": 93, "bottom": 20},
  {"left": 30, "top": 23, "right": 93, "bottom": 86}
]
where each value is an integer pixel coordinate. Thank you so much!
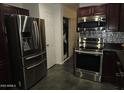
[{"left": 77, "top": 16, "right": 106, "bottom": 32}]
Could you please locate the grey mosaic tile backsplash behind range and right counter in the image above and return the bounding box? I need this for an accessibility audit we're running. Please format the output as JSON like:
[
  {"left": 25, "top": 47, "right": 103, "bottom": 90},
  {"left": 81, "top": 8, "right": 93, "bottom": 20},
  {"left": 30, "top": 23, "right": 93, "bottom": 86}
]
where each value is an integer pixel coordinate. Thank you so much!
[{"left": 80, "top": 31, "right": 124, "bottom": 43}]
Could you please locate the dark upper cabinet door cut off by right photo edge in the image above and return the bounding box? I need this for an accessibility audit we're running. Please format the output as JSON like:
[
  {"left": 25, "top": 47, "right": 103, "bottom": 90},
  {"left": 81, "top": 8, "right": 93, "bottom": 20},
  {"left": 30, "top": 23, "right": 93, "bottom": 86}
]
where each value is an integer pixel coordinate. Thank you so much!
[{"left": 119, "top": 4, "right": 124, "bottom": 32}]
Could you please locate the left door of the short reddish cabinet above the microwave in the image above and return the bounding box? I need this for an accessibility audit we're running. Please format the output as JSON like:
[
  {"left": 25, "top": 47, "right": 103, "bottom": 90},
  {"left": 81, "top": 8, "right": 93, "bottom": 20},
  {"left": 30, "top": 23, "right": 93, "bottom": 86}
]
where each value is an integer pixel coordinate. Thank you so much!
[{"left": 78, "top": 7, "right": 92, "bottom": 17}]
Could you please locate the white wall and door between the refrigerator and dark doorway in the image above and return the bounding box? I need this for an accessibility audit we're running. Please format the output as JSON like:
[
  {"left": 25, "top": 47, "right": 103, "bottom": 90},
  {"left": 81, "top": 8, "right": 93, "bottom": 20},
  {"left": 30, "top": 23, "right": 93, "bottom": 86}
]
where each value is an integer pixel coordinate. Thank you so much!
[{"left": 39, "top": 3, "right": 62, "bottom": 68}]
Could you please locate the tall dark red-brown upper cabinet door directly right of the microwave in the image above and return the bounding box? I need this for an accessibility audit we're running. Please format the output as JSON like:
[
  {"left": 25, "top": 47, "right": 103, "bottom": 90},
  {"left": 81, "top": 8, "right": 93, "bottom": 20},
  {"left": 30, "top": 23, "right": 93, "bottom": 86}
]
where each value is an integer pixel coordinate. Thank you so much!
[{"left": 107, "top": 4, "right": 120, "bottom": 31}]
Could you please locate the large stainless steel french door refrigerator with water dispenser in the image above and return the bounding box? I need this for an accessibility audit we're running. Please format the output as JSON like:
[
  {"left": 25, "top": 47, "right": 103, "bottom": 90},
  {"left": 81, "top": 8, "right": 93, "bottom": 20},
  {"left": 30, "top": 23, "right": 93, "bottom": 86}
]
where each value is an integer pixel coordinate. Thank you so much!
[{"left": 5, "top": 15, "right": 47, "bottom": 89}]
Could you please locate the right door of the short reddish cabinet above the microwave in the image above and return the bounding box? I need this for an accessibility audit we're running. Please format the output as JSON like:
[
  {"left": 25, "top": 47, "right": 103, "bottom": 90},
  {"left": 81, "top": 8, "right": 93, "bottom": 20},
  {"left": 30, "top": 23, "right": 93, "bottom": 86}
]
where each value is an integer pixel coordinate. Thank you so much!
[{"left": 93, "top": 5, "right": 106, "bottom": 15}]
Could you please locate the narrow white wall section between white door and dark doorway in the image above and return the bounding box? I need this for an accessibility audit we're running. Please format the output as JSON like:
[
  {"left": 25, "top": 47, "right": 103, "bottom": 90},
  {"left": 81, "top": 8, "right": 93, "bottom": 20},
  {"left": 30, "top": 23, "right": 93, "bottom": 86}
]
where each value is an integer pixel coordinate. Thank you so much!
[{"left": 54, "top": 4, "right": 64, "bottom": 64}]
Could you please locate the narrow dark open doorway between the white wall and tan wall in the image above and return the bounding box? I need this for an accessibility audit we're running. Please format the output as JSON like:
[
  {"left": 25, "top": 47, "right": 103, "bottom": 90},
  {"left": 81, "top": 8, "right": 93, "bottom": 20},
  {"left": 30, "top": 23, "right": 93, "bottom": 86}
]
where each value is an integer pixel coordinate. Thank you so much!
[{"left": 63, "top": 17, "right": 69, "bottom": 60}]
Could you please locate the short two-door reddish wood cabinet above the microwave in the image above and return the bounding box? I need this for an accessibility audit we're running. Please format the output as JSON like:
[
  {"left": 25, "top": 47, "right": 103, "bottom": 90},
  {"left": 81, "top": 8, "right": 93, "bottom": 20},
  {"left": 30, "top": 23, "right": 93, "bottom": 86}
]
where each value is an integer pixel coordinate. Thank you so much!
[{"left": 78, "top": 5, "right": 106, "bottom": 17}]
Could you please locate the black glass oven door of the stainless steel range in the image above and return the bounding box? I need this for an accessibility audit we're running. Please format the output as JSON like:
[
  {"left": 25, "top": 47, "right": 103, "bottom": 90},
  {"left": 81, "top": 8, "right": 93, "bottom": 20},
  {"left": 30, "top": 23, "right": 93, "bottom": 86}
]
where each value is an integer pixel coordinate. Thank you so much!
[{"left": 76, "top": 51, "right": 102, "bottom": 72}]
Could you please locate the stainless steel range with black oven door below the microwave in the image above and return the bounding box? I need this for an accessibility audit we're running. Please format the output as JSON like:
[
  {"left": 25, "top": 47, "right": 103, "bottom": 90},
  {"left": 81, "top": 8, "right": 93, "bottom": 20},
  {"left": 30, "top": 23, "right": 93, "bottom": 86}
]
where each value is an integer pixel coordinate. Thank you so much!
[{"left": 75, "top": 35, "right": 104, "bottom": 82}]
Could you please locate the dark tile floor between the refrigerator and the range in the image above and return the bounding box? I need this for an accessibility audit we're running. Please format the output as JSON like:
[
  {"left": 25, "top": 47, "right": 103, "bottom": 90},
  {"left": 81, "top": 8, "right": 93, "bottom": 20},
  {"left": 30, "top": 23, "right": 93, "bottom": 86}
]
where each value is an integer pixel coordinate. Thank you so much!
[{"left": 31, "top": 59, "right": 117, "bottom": 90}]
